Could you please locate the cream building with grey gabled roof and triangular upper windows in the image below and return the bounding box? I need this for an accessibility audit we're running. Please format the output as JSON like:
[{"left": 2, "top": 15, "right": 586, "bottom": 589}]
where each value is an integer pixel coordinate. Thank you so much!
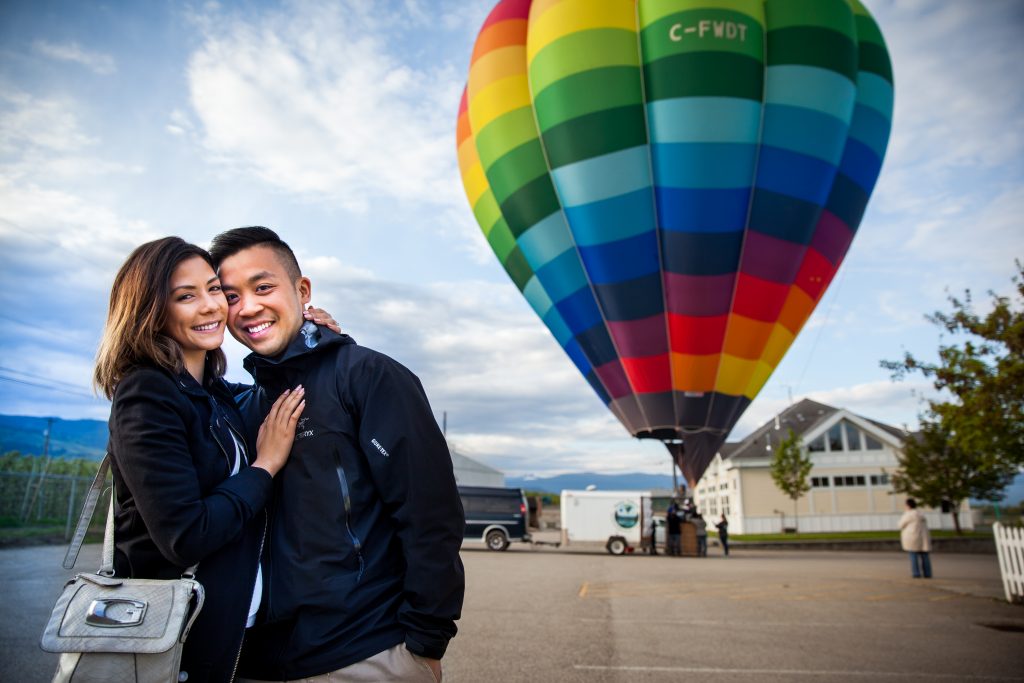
[{"left": 693, "top": 399, "right": 974, "bottom": 533}]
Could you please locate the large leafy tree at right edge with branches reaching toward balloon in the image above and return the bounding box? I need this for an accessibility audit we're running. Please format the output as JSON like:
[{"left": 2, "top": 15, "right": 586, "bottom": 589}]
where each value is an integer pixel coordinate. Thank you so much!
[{"left": 882, "top": 261, "right": 1024, "bottom": 528}]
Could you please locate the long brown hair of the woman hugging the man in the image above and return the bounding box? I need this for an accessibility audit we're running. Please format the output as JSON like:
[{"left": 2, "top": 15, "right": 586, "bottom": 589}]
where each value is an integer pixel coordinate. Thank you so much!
[{"left": 92, "top": 237, "right": 227, "bottom": 398}]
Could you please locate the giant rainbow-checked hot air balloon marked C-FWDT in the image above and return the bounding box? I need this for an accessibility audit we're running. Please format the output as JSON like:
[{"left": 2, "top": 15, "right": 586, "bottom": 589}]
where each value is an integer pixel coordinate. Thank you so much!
[{"left": 457, "top": 0, "right": 893, "bottom": 485}]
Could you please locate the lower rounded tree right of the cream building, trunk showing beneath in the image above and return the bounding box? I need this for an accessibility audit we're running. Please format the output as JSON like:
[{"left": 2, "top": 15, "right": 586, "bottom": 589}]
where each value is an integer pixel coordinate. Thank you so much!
[{"left": 892, "top": 416, "right": 1017, "bottom": 535}]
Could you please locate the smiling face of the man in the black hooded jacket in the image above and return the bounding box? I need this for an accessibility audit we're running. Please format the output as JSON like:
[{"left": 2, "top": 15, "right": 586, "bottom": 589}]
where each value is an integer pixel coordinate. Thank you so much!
[{"left": 220, "top": 246, "right": 311, "bottom": 356}]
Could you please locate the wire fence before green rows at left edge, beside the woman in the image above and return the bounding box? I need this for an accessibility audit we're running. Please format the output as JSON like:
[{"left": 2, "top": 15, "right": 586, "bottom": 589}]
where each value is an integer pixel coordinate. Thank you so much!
[{"left": 0, "top": 472, "right": 111, "bottom": 540}]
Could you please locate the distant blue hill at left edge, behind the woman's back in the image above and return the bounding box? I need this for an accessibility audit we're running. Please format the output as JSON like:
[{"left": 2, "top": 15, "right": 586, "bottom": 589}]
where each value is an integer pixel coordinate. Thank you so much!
[{"left": 0, "top": 415, "right": 108, "bottom": 460}]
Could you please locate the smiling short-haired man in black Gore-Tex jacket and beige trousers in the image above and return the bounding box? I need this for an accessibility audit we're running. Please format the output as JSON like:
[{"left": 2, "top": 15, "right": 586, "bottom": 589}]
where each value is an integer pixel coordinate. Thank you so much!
[{"left": 211, "top": 227, "right": 465, "bottom": 683}]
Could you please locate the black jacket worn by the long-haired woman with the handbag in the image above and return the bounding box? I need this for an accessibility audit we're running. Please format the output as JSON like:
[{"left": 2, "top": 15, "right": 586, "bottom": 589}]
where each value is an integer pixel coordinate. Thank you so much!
[{"left": 108, "top": 367, "right": 271, "bottom": 683}]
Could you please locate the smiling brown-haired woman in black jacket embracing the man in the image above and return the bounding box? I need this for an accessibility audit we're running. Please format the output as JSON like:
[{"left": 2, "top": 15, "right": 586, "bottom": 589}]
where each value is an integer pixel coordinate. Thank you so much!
[{"left": 94, "top": 238, "right": 323, "bottom": 683}]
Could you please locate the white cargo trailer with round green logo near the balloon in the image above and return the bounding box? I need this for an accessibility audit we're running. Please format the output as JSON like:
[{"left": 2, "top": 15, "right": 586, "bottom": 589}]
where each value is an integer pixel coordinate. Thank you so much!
[{"left": 561, "top": 490, "right": 653, "bottom": 555}]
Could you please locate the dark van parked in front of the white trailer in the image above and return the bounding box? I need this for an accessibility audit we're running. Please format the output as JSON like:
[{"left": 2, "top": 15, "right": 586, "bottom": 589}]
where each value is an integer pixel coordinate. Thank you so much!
[{"left": 459, "top": 486, "right": 529, "bottom": 550}]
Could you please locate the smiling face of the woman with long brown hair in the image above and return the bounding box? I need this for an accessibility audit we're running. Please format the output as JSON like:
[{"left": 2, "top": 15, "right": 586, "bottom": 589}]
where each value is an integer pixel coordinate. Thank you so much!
[{"left": 163, "top": 256, "right": 227, "bottom": 358}]
